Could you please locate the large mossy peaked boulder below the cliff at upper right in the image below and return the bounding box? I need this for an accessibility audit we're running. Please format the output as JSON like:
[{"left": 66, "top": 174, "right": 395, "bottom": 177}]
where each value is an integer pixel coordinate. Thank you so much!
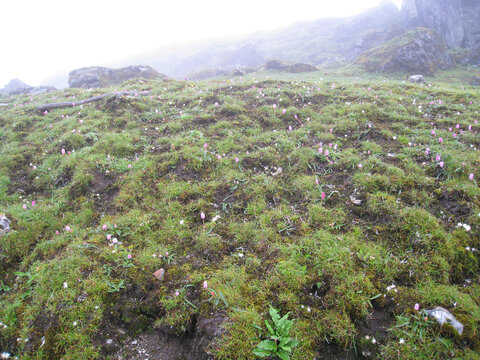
[{"left": 356, "top": 28, "right": 454, "bottom": 75}]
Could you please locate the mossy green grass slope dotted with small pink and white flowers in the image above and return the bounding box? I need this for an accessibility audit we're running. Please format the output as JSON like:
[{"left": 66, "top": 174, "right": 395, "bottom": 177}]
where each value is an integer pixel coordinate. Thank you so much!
[{"left": 0, "top": 69, "right": 480, "bottom": 360}]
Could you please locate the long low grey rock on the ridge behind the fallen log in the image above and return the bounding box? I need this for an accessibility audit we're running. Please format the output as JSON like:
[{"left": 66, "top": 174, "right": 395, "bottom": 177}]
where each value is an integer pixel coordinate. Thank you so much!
[{"left": 68, "top": 65, "right": 167, "bottom": 89}]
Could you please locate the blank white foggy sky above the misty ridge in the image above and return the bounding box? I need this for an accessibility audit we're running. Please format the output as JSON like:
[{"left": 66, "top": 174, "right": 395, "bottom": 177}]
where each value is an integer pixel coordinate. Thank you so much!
[{"left": 0, "top": 0, "right": 402, "bottom": 88}]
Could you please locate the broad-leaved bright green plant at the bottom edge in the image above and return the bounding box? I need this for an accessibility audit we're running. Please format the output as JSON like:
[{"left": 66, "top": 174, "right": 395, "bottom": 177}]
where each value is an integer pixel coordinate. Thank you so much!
[{"left": 253, "top": 306, "right": 298, "bottom": 360}]
